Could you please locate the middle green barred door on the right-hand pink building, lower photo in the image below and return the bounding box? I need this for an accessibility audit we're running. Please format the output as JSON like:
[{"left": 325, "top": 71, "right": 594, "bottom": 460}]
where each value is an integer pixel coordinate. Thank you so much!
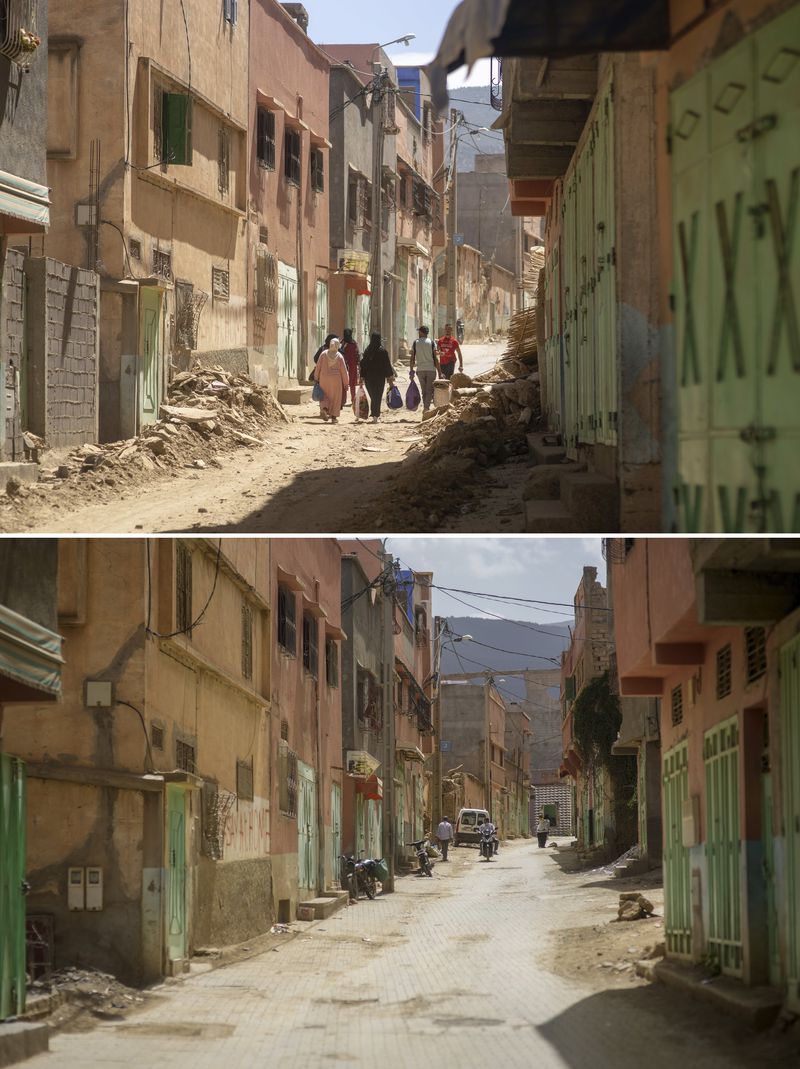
[{"left": 703, "top": 716, "right": 742, "bottom": 976}]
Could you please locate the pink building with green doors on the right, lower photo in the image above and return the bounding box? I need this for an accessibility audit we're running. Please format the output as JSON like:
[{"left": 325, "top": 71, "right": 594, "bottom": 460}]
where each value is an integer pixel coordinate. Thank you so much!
[{"left": 613, "top": 539, "right": 800, "bottom": 1012}]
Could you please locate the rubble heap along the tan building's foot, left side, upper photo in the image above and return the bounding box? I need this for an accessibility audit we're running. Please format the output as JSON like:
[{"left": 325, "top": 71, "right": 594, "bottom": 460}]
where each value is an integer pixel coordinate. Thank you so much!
[{"left": 4, "top": 365, "right": 291, "bottom": 513}]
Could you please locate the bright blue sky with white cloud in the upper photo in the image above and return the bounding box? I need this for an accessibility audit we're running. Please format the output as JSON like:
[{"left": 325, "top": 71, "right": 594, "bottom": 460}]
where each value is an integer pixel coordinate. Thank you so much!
[{"left": 303, "top": 0, "right": 489, "bottom": 89}]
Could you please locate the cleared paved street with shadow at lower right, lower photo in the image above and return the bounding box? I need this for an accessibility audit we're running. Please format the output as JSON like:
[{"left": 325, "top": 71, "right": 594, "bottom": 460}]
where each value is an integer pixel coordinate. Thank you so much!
[{"left": 28, "top": 839, "right": 788, "bottom": 1069}]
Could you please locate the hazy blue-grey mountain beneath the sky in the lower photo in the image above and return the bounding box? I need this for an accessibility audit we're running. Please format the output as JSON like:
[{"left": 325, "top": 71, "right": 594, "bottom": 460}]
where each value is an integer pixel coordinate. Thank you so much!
[{"left": 442, "top": 616, "right": 573, "bottom": 700}]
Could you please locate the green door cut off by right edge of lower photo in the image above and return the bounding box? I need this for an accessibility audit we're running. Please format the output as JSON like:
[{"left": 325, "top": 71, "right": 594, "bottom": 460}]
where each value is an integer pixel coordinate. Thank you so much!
[{"left": 781, "top": 636, "right": 800, "bottom": 1012}]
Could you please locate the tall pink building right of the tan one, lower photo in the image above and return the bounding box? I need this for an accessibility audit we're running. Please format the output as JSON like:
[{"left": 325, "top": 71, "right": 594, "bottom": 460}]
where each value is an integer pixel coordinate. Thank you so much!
[{"left": 271, "top": 539, "right": 344, "bottom": 920}]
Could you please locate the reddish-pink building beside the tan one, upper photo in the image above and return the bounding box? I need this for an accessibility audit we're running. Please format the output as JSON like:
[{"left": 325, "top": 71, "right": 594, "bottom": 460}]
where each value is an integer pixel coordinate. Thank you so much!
[{"left": 243, "top": 0, "right": 330, "bottom": 400}]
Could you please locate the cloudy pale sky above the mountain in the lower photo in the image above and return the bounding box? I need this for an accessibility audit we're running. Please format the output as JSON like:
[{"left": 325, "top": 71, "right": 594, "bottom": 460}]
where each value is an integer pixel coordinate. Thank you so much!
[{"left": 388, "top": 535, "right": 605, "bottom": 623}]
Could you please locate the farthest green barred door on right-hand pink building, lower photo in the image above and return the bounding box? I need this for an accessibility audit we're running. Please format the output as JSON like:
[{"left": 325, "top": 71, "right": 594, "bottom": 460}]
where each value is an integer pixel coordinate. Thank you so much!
[{"left": 662, "top": 742, "right": 692, "bottom": 957}]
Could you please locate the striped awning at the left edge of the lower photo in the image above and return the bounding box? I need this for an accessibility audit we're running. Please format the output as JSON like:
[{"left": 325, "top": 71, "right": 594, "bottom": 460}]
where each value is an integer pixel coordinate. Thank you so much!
[{"left": 0, "top": 605, "right": 64, "bottom": 701}]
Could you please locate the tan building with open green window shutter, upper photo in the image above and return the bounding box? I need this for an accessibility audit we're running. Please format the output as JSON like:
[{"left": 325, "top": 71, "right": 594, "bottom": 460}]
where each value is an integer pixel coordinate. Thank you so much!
[{"left": 44, "top": 0, "right": 250, "bottom": 441}]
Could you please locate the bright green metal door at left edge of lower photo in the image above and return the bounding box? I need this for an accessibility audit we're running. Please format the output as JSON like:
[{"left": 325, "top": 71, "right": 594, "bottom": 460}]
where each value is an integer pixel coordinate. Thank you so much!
[{"left": 0, "top": 754, "right": 26, "bottom": 1021}]
